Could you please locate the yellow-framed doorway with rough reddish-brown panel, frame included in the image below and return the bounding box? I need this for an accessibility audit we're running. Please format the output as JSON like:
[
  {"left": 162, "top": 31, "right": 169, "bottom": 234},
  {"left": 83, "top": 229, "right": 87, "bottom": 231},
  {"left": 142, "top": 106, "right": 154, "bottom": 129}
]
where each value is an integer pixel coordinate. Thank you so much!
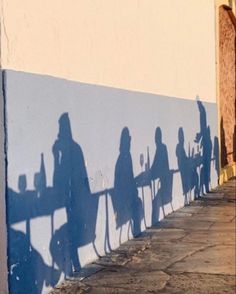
[{"left": 215, "top": 0, "right": 236, "bottom": 184}]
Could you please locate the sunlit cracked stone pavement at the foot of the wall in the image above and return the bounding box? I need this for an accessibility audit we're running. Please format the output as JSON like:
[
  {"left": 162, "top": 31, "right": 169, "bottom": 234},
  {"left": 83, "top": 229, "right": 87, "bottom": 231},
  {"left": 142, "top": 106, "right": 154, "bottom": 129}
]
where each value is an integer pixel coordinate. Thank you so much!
[{"left": 51, "top": 179, "right": 236, "bottom": 294}]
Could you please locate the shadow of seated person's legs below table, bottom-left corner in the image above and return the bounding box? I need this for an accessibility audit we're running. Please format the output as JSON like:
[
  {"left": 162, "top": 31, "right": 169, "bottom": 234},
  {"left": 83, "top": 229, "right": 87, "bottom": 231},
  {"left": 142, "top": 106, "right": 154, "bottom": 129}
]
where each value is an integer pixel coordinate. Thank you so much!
[{"left": 8, "top": 228, "right": 60, "bottom": 294}]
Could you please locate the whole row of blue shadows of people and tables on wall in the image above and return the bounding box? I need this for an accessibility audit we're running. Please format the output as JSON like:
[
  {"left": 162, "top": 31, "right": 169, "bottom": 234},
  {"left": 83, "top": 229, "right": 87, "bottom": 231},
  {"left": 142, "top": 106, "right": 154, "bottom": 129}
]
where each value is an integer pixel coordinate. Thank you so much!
[{"left": 7, "top": 101, "right": 219, "bottom": 294}]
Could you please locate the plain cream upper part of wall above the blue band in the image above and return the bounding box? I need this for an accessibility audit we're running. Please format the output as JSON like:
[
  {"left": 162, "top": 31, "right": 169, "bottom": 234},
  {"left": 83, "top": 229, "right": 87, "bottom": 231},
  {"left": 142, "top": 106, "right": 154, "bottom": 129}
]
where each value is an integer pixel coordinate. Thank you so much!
[{"left": 1, "top": 0, "right": 216, "bottom": 102}]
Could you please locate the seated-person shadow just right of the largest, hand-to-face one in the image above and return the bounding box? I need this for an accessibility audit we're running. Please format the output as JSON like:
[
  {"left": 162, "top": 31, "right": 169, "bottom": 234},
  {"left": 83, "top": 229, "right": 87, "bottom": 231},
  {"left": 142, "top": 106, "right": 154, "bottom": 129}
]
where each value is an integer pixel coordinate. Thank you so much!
[{"left": 112, "top": 127, "right": 142, "bottom": 243}]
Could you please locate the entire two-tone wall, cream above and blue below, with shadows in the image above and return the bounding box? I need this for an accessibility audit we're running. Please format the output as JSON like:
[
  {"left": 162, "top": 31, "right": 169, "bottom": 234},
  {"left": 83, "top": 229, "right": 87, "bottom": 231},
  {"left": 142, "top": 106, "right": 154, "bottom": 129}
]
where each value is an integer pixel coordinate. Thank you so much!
[{"left": 1, "top": 0, "right": 219, "bottom": 293}]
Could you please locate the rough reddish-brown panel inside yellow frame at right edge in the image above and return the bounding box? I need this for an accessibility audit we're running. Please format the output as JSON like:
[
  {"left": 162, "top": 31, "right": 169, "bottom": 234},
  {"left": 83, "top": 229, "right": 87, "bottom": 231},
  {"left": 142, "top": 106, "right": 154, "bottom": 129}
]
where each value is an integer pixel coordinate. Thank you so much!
[{"left": 219, "top": 6, "right": 236, "bottom": 167}]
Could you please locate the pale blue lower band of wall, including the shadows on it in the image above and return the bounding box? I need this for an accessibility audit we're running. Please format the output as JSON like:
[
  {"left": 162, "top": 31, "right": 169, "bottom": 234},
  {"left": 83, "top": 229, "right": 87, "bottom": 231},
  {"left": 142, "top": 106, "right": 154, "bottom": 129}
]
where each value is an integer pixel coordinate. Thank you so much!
[{"left": 4, "top": 71, "right": 218, "bottom": 294}]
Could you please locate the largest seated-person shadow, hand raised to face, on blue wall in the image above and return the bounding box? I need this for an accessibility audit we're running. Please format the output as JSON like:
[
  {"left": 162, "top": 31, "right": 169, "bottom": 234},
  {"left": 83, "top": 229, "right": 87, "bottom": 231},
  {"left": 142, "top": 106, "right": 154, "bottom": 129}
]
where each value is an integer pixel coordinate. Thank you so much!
[{"left": 50, "top": 113, "right": 98, "bottom": 274}]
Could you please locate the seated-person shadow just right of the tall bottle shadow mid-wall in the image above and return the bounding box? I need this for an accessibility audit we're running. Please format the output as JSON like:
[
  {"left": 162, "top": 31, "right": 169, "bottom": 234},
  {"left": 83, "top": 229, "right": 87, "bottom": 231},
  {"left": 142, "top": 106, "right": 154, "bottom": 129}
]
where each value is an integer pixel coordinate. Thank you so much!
[{"left": 150, "top": 127, "right": 173, "bottom": 224}]
